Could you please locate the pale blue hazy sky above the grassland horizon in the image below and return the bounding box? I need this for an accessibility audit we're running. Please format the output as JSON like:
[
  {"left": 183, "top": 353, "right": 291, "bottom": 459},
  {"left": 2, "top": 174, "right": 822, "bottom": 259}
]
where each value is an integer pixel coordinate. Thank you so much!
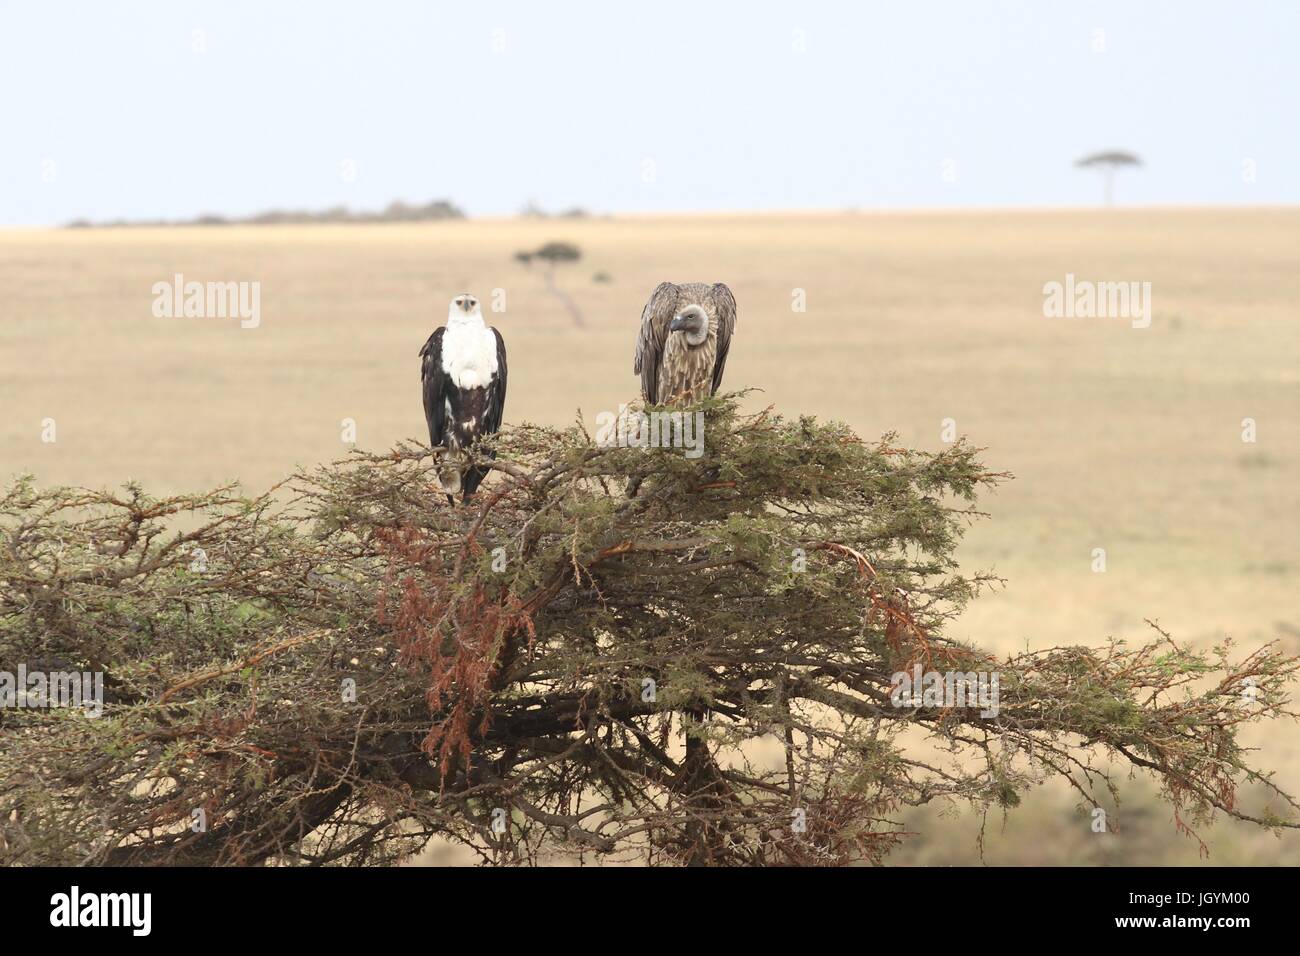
[{"left": 0, "top": 0, "right": 1300, "bottom": 225}]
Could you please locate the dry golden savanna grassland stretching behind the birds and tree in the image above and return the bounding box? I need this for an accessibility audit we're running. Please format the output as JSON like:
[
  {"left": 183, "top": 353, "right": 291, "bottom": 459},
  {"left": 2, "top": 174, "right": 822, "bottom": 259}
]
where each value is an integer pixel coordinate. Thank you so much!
[{"left": 0, "top": 209, "right": 1300, "bottom": 864}]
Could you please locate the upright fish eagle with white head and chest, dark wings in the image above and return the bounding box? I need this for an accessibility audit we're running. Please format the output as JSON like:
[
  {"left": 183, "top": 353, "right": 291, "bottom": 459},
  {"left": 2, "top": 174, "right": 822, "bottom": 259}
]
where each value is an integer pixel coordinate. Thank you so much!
[{"left": 420, "top": 293, "right": 506, "bottom": 503}]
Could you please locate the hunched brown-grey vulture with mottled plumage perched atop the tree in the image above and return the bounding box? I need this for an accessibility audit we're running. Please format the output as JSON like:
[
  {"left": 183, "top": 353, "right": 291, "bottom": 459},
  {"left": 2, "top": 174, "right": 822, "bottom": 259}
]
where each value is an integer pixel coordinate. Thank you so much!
[{"left": 632, "top": 282, "right": 736, "bottom": 405}]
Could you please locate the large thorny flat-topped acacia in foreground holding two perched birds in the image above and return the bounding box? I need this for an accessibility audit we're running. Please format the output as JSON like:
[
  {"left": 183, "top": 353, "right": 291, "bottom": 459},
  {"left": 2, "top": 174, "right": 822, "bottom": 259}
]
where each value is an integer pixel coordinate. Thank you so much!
[{"left": 0, "top": 398, "right": 1297, "bottom": 865}]
